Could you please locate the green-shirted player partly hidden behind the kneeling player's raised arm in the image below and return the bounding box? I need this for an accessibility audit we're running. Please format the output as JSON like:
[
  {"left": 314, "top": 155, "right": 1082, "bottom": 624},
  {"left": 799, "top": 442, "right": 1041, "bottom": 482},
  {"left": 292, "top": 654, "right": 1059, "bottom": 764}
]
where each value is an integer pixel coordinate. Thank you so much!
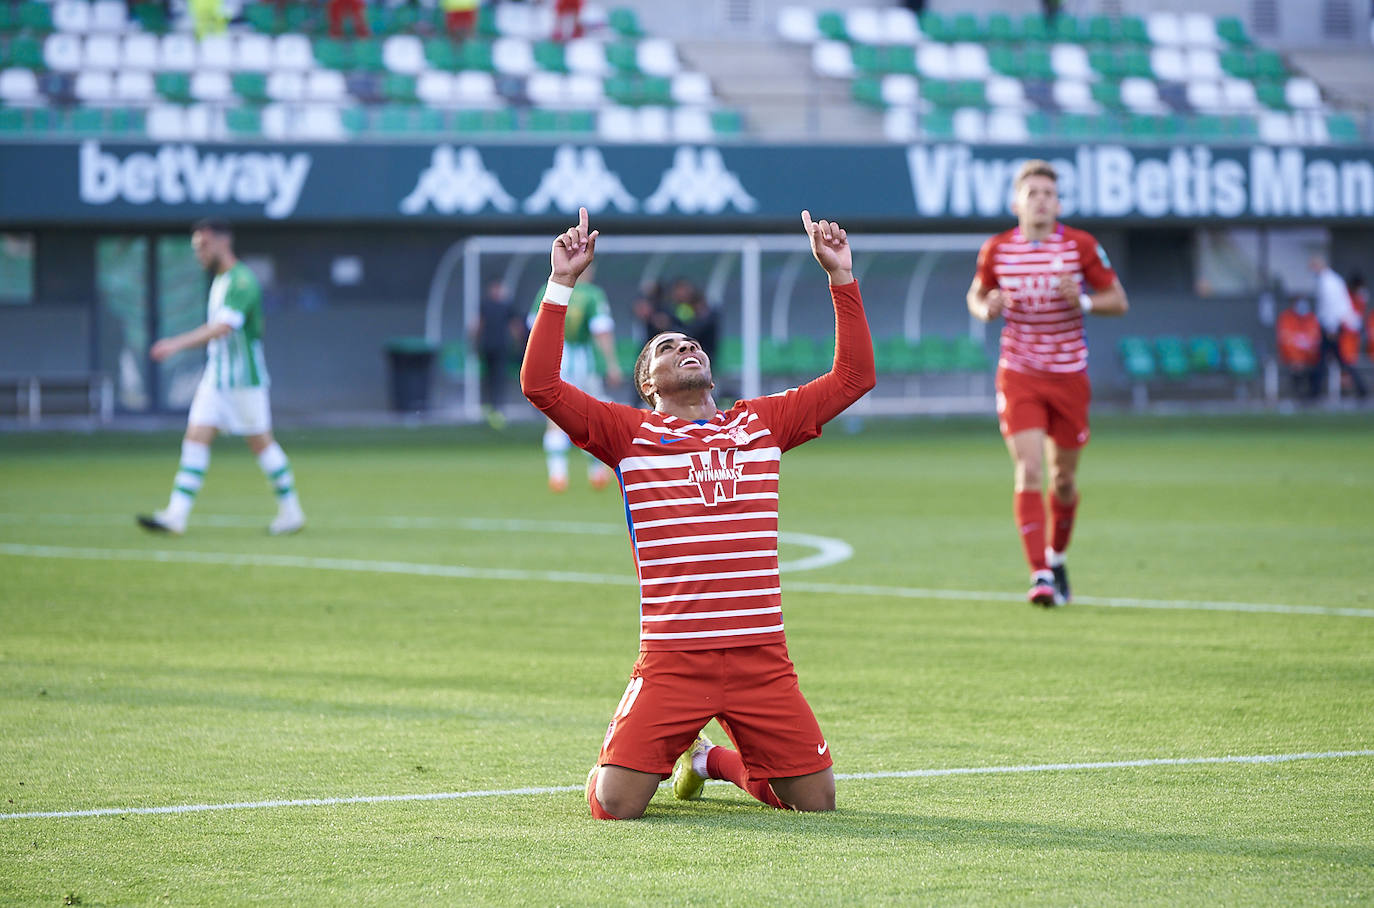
[{"left": 529, "top": 258, "right": 621, "bottom": 492}]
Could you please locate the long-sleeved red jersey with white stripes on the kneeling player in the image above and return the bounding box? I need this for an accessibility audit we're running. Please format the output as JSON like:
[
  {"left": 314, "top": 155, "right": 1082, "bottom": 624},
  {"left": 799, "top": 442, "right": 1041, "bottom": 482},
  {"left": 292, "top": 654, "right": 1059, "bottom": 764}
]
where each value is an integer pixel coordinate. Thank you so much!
[{"left": 521, "top": 284, "right": 874, "bottom": 650}]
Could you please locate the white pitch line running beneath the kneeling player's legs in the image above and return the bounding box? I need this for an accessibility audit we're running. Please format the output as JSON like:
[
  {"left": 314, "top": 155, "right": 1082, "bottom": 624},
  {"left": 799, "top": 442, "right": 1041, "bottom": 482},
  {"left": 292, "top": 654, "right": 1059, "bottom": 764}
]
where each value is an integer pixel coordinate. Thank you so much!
[{"left": 0, "top": 750, "right": 1374, "bottom": 820}]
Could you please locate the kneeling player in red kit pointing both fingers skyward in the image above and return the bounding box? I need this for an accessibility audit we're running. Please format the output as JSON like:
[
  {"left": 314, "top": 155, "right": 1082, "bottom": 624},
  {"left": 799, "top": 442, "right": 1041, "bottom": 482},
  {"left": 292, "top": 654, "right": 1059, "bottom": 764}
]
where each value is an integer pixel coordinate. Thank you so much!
[{"left": 521, "top": 209, "right": 875, "bottom": 820}]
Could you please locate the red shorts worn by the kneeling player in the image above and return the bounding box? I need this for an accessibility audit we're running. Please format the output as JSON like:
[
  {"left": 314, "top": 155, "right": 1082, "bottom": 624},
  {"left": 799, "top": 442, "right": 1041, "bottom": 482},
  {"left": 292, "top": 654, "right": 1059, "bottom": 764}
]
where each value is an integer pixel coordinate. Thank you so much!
[{"left": 598, "top": 643, "right": 831, "bottom": 779}]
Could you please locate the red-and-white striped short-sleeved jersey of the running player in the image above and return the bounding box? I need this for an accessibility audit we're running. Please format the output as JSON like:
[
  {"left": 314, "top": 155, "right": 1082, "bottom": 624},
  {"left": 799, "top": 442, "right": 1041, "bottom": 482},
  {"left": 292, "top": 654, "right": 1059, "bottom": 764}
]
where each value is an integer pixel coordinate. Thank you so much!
[{"left": 978, "top": 224, "right": 1116, "bottom": 374}]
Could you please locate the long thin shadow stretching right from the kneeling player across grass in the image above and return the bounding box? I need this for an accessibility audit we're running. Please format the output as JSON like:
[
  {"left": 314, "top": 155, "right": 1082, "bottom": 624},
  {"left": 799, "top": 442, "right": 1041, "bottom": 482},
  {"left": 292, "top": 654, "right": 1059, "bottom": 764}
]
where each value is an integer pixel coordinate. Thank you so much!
[{"left": 644, "top": 788, "right": 1374, "bottom": 868}]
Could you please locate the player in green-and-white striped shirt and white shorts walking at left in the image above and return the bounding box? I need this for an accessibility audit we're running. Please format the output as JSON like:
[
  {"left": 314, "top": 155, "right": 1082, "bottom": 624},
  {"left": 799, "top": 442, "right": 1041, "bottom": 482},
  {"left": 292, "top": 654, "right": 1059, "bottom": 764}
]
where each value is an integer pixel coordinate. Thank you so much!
[{"left": 139, "top": 220, "right": 305, "bottom": 536}]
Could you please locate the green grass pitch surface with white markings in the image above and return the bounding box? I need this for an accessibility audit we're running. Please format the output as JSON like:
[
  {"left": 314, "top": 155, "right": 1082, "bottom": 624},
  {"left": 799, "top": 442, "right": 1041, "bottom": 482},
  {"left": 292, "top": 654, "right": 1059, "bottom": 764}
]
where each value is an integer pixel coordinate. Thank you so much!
[{"left": 0, "top": 415, "right": 1374, "bottom": 905}]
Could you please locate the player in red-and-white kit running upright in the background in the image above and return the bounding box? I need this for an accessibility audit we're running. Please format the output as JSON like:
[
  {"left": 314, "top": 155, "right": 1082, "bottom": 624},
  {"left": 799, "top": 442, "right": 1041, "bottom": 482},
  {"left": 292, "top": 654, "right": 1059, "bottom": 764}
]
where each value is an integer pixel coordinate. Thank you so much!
[{"left": 967, "top": 161, "right": 1127, "bottom": 607}]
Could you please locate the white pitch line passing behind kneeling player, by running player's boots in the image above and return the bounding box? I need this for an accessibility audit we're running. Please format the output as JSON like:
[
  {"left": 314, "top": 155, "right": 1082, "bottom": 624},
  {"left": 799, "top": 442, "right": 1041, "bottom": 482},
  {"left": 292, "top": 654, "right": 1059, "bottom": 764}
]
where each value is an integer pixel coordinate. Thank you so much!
[{"left": 0, "top": 533, "right": 1374, "bottom": 618}]
